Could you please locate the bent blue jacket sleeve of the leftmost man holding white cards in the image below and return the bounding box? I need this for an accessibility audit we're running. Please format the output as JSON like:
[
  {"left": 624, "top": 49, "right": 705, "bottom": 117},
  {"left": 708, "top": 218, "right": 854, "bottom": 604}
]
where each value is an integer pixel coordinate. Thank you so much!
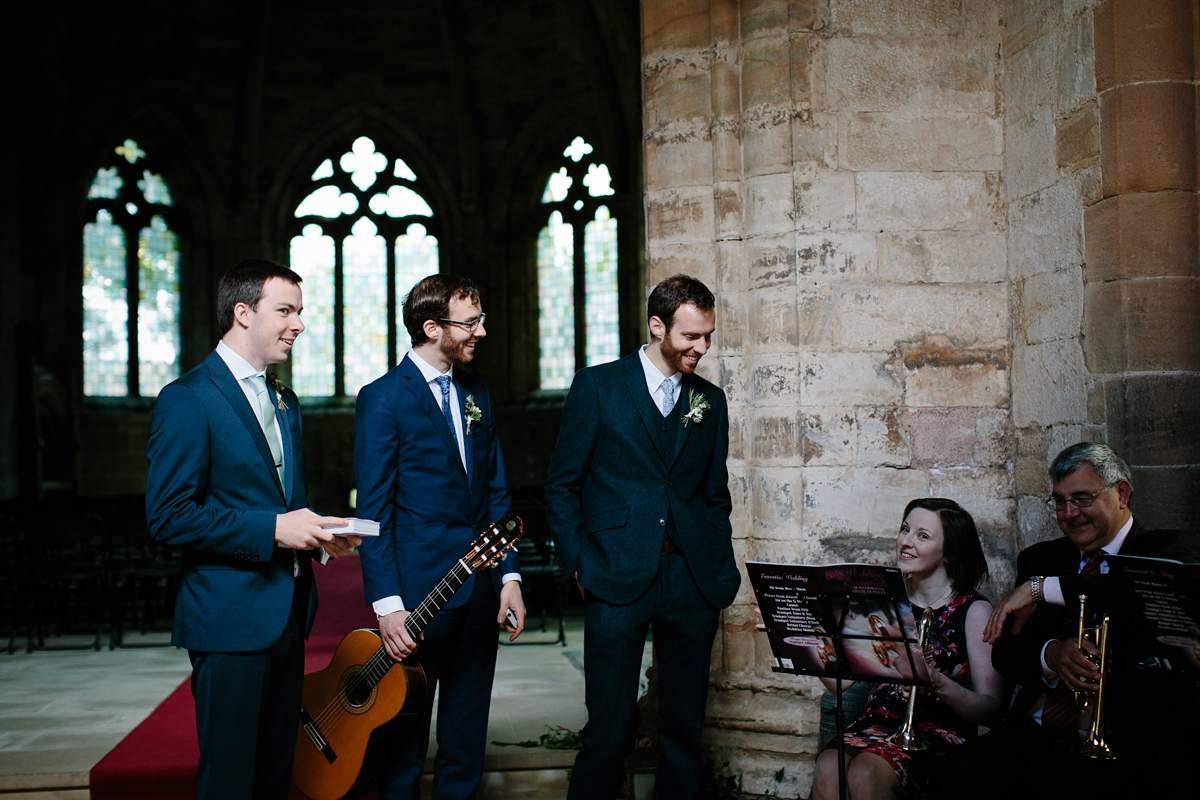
[{"left": 146, "top": 383, "right": 276, "bottom": 561}]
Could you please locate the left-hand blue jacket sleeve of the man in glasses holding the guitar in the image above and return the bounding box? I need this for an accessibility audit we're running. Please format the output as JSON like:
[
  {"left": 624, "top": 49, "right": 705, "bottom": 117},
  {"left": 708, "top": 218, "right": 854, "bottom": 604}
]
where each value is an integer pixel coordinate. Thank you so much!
[{"left": 354, "top": 384, "right": 401, "bottom": 603}]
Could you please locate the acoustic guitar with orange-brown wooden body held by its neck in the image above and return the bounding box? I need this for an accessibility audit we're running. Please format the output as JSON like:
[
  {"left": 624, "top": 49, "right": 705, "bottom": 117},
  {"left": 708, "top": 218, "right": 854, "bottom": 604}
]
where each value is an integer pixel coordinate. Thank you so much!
[{"left": 292, "top": 513, "right": 524, "bottom": 800}]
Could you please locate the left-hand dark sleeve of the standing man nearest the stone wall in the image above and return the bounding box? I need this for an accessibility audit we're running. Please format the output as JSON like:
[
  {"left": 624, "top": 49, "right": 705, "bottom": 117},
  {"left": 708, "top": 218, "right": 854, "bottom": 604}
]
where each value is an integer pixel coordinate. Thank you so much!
[{"left": 546, "top": 369, "right": 600, "bottom": 575}]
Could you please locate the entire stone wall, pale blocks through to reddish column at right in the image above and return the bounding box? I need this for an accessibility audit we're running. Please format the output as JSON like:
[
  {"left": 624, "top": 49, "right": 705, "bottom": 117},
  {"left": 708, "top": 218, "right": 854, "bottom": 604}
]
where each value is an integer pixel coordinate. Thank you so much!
[{"left": 642, "top": 0, "right": 1200, "bottom": 796}]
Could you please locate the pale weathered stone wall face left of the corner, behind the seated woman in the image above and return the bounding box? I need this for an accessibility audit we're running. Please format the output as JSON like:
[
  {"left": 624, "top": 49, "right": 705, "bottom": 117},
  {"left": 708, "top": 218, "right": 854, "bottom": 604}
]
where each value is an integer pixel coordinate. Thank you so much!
[{"left": 642, "top": 0, "right": 1015, "bottom": 796}]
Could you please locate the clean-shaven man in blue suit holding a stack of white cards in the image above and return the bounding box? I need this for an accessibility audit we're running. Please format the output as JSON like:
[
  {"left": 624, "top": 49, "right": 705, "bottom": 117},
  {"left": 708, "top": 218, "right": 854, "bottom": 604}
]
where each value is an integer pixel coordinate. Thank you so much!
[{"left": 146, "top": 260, "right": 359, "bottom": 800}]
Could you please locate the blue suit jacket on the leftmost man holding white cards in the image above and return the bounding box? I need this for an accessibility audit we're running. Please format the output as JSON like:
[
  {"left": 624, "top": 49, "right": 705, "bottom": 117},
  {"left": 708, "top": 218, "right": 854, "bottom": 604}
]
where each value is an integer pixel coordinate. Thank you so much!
[{"left": 146, "top": 351, "right": 317, "bottom": 652}]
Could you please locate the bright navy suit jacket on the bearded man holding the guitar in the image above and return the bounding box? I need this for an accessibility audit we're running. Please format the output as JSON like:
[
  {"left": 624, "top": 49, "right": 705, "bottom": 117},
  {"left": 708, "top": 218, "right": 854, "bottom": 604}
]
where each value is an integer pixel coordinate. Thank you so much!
[{"left": 354, "top": 355, "right": 520, "bottom": 609}]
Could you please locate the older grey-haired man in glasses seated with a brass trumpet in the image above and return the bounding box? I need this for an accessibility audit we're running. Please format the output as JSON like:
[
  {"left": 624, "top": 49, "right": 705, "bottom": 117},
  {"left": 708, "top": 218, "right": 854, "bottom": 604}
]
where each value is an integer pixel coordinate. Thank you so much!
[{"left": 942, "top": 441, "right": 1200, "bottom": 800}]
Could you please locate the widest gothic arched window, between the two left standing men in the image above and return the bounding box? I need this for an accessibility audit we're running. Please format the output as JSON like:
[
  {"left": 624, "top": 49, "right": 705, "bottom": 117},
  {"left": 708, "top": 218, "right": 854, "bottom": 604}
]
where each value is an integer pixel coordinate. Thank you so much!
[{"left": 290, "top": 137, "right": 439, "bottom": 397}]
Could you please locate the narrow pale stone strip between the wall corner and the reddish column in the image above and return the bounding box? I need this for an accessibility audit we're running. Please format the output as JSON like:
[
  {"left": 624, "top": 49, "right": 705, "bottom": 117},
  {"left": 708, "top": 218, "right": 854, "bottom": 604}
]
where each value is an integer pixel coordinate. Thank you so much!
[{"left": 1002, "top": 1, "right": 1103, "bottom": 547}]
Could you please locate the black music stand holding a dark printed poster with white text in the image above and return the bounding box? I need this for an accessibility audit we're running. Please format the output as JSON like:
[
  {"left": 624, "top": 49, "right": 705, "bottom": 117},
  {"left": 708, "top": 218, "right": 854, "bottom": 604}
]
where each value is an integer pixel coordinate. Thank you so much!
[{"left": 746, "top": 561, "right": 931, "bottom": 800}]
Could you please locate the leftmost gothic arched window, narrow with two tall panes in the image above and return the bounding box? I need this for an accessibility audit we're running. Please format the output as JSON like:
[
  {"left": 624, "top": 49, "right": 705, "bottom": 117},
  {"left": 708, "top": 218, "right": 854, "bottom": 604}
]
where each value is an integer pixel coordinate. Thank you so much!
[{"left": 83, "top": 139, "right": 180, "bottom": 397}]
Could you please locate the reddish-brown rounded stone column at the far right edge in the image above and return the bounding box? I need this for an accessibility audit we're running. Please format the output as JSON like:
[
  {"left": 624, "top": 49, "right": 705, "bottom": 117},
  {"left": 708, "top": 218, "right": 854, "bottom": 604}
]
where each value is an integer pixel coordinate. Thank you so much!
[{"left": 1084, "top": 0, "right": 1200, "bottom": 530}]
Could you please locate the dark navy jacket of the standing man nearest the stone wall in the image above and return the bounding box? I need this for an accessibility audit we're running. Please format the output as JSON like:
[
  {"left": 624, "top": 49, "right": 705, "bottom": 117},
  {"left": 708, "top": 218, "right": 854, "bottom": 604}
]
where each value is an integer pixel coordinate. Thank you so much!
[{"left": 546, "top": 350, "right": 742, "bottom": 608}]
